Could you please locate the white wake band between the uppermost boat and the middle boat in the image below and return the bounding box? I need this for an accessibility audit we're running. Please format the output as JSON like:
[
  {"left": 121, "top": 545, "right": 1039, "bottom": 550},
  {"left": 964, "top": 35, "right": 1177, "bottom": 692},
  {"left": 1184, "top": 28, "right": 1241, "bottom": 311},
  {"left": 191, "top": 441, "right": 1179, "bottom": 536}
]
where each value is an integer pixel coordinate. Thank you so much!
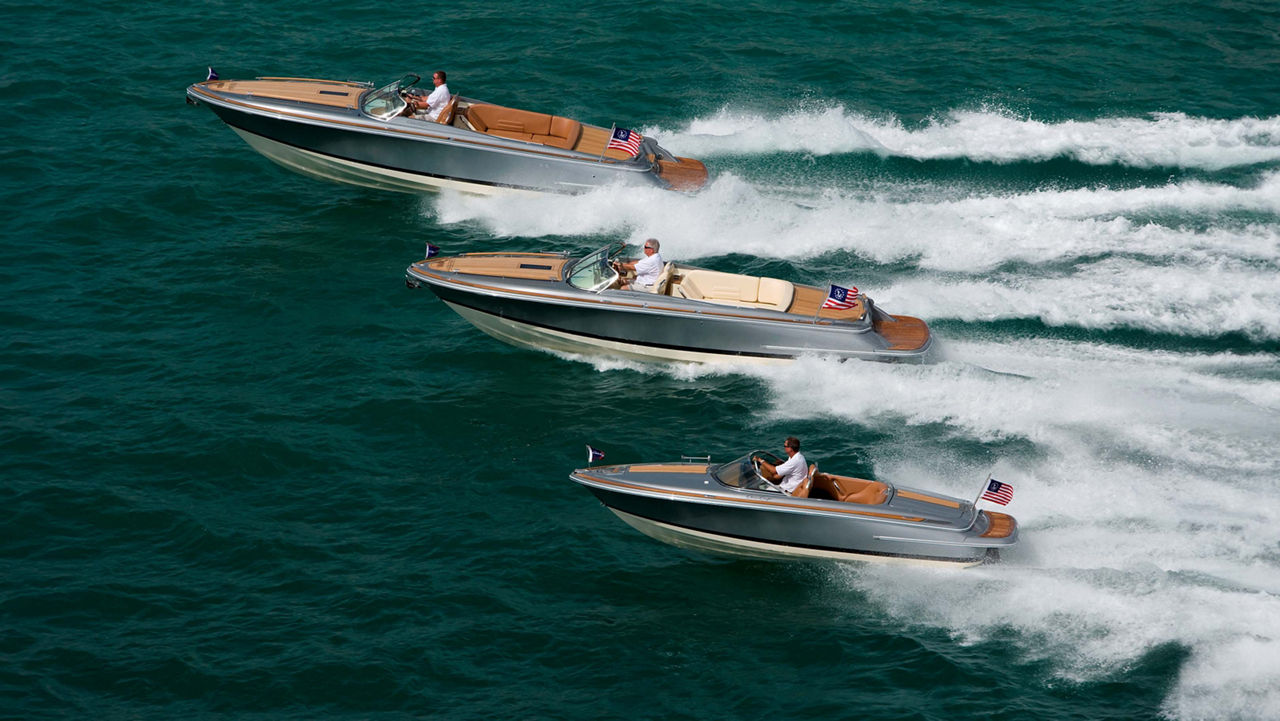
[{"left": 428, "top": 172, "right": 1280, "bottom": 342}]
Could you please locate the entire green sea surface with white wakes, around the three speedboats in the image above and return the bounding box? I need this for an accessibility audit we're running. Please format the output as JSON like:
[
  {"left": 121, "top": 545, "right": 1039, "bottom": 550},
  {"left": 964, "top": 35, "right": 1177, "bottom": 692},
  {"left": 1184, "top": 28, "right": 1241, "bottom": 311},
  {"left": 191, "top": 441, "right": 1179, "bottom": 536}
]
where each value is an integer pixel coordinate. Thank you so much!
[{"left": 0, "top": 0, "right": 1280, "bottom": 720}]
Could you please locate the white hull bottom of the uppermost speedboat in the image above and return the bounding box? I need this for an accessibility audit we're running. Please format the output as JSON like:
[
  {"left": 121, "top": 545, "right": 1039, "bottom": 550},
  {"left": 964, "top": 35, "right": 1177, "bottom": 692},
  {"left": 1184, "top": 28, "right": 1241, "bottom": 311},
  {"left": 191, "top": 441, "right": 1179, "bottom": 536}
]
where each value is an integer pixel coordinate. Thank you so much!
[{"left": 232, "top": 127, "right": 529, "bottom": 195}]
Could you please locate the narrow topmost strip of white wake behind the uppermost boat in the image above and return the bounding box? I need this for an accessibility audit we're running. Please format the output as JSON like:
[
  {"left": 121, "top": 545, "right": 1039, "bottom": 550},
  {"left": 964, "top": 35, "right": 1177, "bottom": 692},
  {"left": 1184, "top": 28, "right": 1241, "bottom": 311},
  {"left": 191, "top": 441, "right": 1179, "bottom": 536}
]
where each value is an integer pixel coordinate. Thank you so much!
[{"left": 643, "top": 105, "right": 1280, "bottom": 170}]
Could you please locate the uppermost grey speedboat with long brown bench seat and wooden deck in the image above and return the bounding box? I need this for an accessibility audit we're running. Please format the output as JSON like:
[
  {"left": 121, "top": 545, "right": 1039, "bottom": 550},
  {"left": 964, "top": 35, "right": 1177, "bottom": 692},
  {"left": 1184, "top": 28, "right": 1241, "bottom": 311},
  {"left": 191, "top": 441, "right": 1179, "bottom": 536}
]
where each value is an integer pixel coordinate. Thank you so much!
[{"left": 187, "top": 73, "right": 707, "bottom": 193}]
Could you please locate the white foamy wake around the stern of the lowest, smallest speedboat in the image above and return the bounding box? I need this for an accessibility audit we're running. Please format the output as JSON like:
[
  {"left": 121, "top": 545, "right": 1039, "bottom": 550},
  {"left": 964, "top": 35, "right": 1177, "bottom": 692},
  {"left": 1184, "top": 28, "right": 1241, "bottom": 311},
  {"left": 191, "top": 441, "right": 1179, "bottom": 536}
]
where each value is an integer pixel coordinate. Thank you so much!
[{"left": 737, "top": 341, "right": 1280, "bottom": 718}]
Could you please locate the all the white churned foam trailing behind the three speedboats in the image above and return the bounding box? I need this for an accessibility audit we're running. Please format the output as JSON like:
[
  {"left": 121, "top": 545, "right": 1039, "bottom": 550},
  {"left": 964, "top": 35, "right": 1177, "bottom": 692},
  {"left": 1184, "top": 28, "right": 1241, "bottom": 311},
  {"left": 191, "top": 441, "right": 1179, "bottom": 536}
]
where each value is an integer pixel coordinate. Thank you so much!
[{"left": 426, "top": 106, "right": 1280, "bottom": 718}]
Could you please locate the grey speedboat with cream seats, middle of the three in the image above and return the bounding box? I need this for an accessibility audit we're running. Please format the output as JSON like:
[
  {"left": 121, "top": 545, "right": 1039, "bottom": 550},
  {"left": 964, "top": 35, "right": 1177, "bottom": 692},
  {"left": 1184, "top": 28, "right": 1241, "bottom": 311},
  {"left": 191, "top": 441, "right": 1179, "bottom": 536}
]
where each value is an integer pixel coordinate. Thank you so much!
[{"left": 406, "top": 243, "right": 933, "bottom": 362}]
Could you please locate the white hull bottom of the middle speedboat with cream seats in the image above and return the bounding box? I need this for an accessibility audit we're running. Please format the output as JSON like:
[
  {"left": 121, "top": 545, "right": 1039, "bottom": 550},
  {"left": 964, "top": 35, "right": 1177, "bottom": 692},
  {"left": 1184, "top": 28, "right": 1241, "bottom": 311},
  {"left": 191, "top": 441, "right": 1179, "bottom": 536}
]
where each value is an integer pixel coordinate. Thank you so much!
[{"left": 445, "top": 301, "right": 791, "bottom": 365}]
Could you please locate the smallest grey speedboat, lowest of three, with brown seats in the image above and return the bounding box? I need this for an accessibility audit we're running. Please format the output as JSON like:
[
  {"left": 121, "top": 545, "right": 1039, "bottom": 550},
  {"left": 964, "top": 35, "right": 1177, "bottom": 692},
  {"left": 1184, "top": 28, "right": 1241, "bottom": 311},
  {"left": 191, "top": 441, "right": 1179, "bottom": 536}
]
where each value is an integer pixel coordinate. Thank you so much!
[{"left": 570, "top": 451, "right": 1018, "bottom": 566}]
